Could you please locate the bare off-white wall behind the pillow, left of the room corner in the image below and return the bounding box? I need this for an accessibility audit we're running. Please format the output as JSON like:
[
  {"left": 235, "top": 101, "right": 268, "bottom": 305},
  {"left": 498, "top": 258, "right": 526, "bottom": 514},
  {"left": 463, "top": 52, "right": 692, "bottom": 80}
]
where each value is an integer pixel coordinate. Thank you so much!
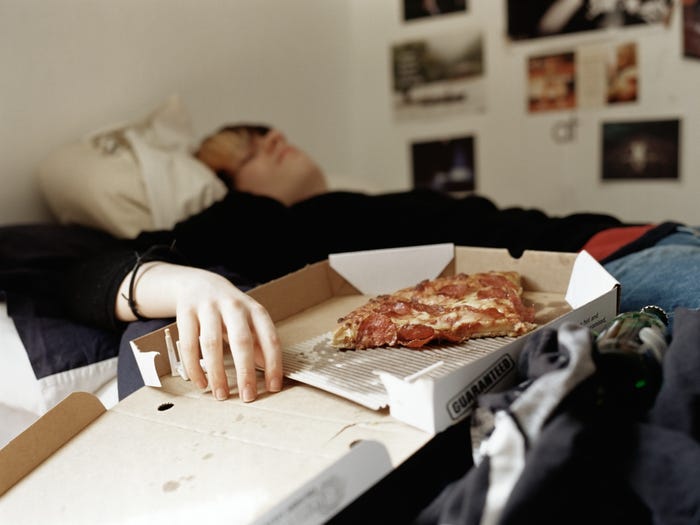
[{"left": 0, "top": 0, "right": 350, "bottom": 223}]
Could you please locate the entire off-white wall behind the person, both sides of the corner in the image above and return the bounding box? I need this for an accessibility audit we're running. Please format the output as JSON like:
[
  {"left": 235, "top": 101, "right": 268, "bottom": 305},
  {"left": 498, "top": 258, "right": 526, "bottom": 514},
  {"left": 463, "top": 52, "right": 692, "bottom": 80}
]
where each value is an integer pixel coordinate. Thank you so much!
[{"left": 0, "top": 0, "right": 700, "bottom": 224}]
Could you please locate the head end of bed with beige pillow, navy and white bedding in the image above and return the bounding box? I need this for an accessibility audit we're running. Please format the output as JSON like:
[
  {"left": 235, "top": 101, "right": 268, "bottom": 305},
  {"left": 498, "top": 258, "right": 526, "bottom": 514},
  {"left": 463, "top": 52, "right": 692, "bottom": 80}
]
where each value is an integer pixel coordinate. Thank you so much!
[{"left": 0, "top": 95, "right": 380, "bottom": 446}]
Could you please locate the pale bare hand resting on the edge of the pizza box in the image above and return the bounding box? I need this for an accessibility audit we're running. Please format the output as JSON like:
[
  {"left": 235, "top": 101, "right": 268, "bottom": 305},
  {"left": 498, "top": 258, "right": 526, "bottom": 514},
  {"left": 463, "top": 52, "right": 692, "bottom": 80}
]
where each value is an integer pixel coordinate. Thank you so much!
[{"left": 117, "top": 262, "right": 283, "bottom": 402}]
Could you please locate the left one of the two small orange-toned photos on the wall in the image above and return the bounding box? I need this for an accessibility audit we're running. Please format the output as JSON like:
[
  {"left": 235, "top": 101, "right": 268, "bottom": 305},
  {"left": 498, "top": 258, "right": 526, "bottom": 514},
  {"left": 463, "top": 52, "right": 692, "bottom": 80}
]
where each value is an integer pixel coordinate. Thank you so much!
[{"left": 527, "top": 52, "right": 576, "bottom": 113}]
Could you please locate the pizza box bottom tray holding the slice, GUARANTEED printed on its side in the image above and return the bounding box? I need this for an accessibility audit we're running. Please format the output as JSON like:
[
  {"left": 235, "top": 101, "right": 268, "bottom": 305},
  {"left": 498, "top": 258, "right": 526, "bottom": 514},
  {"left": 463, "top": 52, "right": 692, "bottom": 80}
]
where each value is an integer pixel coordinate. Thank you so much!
[{"left": 132, "top": 244, "right": 619, "bottom": 433}]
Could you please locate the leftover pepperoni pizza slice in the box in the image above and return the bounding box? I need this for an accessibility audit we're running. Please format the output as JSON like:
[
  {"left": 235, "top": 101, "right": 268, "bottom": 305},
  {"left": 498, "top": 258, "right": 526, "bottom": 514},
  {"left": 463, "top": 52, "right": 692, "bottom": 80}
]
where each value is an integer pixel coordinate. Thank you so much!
[{"left": 330, "top": 271, "right": 537, "bottom": 350}]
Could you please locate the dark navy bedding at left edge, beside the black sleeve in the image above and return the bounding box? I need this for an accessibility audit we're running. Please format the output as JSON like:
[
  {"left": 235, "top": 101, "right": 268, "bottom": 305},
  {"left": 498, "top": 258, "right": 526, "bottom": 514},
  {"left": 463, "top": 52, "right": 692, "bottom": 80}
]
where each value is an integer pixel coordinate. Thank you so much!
[{"left": 0, "top": 224, "right": 120, "bottom": 379}]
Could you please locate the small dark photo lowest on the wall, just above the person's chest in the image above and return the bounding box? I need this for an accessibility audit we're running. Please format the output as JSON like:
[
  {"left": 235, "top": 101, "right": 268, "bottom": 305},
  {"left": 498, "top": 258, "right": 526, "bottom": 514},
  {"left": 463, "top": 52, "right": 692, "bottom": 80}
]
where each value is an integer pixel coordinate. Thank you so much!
[{"left": 411, "top": 136, "right": 476, "bottom": 193}]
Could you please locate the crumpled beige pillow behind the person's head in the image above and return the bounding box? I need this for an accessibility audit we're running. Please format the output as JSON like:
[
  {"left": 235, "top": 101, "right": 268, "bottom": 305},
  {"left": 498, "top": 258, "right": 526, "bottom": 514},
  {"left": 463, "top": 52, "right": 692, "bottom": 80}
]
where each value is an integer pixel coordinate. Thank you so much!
[{"left": 37, "top": 95, "right": 226, "bottom": 238}]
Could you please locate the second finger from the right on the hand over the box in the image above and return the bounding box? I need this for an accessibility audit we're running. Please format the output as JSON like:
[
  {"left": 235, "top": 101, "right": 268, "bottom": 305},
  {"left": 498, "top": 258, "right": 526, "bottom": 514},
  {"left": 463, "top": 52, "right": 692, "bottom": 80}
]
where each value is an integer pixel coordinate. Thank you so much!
[{"left": 222, "top": 302, "right": 258, "bottom": 402}]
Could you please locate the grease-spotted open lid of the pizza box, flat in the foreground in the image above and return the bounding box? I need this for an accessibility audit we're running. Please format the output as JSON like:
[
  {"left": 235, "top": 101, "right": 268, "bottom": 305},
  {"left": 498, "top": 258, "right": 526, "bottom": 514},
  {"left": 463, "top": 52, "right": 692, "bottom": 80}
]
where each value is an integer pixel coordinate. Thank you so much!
[{"left": 0, "top": 376, "right": 432, "bottom": 525}]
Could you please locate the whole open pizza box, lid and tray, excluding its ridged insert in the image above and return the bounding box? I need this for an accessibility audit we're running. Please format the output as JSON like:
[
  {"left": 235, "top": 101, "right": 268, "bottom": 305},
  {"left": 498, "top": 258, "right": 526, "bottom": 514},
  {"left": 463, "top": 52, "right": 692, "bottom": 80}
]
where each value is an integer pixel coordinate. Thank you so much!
[{"left": 0, "top": 245, "right": 618, "bottom": 525}]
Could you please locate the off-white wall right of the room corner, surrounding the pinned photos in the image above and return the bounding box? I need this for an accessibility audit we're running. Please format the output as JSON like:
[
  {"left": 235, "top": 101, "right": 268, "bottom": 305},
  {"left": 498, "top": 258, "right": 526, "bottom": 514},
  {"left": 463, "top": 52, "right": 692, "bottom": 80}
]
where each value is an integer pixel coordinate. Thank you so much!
[{"left": 352, "top": 0, "right": 700, "bottom": 224}]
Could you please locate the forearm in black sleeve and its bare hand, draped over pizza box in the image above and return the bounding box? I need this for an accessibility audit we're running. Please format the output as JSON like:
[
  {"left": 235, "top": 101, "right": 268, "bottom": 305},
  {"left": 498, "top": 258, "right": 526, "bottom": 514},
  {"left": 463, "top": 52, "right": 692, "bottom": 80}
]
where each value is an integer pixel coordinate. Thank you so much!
[{"left": 62, "top": 247, "right": 283, "bottom": 401}]
